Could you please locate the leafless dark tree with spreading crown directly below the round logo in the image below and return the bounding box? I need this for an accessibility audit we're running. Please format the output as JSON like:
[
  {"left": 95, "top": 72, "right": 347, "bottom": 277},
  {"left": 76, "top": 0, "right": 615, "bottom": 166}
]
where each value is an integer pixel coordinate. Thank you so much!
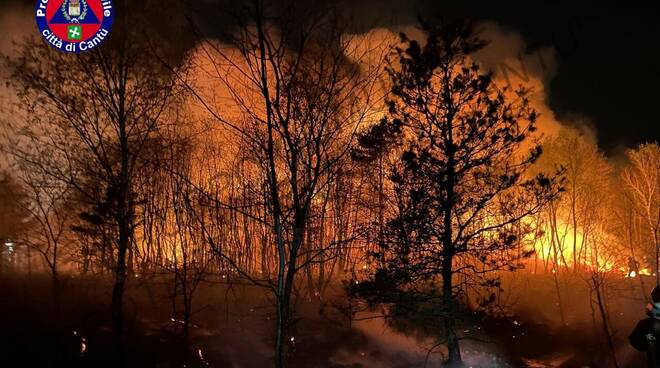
[{"left": 3, "top": 7, "right": 184, "bottom": 365}]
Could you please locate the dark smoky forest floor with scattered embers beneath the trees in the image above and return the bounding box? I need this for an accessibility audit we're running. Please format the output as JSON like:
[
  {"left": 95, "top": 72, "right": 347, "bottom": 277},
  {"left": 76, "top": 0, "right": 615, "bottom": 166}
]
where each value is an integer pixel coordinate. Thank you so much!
[{"left": 0, "top": 275, "right": 643, "bottom": 368}]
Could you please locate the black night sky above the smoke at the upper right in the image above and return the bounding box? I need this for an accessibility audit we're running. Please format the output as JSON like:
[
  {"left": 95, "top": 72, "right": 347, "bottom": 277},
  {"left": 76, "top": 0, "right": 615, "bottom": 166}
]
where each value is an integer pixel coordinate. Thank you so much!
[{"left": 428, "top": 1, "right": 660, "bottom": 155}]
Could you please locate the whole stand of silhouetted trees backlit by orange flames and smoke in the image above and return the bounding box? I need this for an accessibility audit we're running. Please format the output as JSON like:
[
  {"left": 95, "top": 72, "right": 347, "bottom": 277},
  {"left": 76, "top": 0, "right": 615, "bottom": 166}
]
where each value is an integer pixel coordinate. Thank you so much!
[{"left": 0, "top": 1, "right": 660, "bottom": 367}]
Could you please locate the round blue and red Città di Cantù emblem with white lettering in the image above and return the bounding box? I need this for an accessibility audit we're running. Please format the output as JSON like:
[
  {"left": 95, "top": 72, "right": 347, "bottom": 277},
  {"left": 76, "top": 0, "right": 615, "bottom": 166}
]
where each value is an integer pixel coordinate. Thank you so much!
[{"left": 36, "top": 0, "right": 114, "bottom": 53}]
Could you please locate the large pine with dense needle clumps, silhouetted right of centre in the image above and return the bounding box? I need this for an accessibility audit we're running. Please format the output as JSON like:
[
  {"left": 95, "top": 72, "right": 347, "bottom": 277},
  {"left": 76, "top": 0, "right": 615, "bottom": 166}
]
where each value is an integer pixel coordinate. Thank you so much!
[{"left": 357, "top": 22, "right": 558, "bottom": 366}]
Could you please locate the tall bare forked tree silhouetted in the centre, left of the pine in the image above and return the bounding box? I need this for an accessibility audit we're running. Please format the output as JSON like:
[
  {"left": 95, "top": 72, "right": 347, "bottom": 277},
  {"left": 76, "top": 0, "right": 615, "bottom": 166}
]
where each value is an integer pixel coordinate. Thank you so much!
[{"left": 175, "top": 0, "right": 379, "bottom": 367}]
